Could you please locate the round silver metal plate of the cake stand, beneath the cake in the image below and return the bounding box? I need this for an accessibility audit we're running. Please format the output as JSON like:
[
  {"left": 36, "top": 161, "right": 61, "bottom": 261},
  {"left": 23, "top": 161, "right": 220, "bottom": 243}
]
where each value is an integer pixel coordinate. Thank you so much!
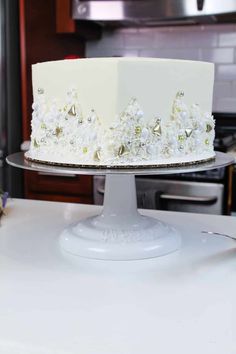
[{"left": 6, "top": 152, "right": 234, "bottom": 175}]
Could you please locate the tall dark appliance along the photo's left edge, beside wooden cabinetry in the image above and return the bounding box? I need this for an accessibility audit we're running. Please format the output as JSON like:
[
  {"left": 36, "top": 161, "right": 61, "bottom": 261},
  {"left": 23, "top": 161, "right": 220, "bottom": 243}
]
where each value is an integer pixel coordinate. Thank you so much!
[{"left": 0, "top": 0, "right": 23, "bottom": 197}]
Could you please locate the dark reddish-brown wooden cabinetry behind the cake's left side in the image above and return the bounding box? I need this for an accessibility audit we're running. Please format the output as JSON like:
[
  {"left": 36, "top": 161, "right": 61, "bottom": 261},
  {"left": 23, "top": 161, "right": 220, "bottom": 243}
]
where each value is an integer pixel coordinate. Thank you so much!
[{"left": 19, "top": 0, "right": 93, "bottom": 203}]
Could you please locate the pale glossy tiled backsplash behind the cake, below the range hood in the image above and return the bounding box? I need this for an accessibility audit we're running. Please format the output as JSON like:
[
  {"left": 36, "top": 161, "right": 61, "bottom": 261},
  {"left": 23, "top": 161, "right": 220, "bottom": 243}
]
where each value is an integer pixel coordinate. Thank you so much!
[{"left": 86, "top": 24, "right": 236, "bottom": 112}]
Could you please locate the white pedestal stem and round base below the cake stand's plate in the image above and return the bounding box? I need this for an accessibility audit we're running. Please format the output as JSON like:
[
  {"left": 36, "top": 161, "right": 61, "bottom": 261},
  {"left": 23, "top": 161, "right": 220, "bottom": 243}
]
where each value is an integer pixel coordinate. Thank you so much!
[{"left": 59, "top": 174, "right": 181, "bottom": 260}]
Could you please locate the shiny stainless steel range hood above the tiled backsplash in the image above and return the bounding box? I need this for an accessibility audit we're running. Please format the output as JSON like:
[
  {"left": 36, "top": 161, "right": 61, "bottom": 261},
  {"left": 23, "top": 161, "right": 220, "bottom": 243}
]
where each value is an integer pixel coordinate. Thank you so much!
[{"left": 72, "top": 0, "right": 236, "bottom": 25}]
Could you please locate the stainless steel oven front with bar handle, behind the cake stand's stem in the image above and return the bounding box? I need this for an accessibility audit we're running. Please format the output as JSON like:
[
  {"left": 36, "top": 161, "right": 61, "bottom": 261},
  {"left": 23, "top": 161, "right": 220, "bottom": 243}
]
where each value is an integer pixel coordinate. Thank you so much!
[{"left": 94, "top": 176, "right": 224, "bottom": 214}]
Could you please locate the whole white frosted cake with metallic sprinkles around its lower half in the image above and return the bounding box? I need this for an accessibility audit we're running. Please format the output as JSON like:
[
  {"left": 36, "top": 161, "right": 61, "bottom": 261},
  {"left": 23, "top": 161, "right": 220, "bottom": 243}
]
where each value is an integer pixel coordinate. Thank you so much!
[{"left": 27, "top": 58, "right": 214, "bottom": 166}]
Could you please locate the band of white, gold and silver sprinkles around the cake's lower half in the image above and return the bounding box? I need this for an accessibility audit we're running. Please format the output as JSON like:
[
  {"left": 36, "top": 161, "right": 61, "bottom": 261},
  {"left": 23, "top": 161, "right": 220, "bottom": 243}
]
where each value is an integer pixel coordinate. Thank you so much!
[{"left": 28, "top": 89, "right": 214, "bottom": 163}]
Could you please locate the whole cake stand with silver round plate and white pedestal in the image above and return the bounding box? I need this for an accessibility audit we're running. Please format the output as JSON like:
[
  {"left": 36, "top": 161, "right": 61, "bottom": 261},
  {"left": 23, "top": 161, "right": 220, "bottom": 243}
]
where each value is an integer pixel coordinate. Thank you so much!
[{"left": 7, "top": 152, "right": 234, "bottom": 260}]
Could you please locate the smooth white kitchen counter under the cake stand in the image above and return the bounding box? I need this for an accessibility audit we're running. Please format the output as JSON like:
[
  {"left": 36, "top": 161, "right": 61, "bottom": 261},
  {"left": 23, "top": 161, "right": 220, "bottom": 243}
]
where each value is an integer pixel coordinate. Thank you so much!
[{"left": 0, "top": 199, "right": 236, "bottom": 354}]
